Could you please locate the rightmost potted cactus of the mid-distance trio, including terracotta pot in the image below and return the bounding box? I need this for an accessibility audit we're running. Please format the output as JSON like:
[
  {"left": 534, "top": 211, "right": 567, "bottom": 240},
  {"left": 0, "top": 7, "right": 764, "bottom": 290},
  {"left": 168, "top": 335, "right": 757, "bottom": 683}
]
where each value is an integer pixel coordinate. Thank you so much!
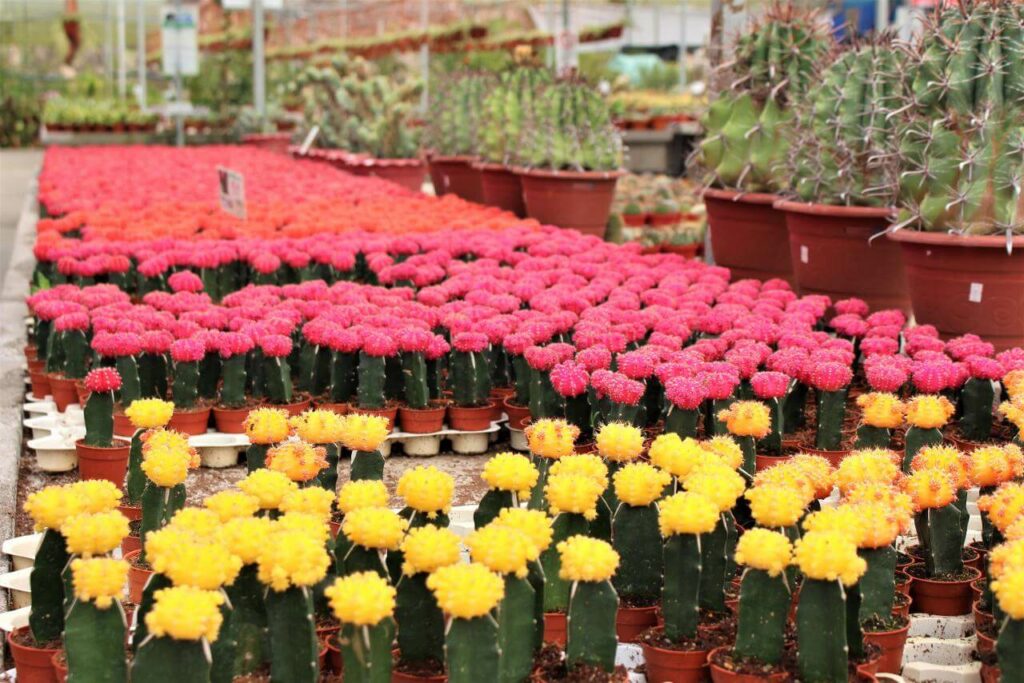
[{"left": 516, "top": 79, "right": 623, "bottom": 238}]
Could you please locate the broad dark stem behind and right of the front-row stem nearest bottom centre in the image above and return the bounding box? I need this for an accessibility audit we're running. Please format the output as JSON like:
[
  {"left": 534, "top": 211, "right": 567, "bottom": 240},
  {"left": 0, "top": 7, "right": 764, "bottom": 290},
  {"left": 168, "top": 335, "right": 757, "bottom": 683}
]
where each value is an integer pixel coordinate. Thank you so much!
[{"left": 611, "top": 503, "right": 665, "bottom": 604}]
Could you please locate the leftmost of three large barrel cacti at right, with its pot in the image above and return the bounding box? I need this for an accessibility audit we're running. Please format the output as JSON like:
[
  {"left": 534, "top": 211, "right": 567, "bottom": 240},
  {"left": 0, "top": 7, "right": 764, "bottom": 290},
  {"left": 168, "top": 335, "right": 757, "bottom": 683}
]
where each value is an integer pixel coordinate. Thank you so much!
[{"left": 696, "top": 3, "right": 833, "bottom": 281}]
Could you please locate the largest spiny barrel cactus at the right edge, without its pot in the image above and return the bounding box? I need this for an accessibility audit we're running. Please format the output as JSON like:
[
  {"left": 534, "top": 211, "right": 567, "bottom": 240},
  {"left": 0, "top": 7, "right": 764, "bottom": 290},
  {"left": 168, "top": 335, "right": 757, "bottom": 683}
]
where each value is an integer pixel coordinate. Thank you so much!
[{"left": 894, "top": 0, "right": 1024, "bottom": 234}]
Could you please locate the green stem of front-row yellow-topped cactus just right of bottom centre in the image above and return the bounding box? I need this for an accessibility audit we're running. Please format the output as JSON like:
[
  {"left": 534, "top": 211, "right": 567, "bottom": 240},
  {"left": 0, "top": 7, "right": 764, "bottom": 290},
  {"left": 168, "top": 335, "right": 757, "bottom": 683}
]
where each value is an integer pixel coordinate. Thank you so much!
[{"left": 565, "top": 581, "right": 618, "bottom": 673}]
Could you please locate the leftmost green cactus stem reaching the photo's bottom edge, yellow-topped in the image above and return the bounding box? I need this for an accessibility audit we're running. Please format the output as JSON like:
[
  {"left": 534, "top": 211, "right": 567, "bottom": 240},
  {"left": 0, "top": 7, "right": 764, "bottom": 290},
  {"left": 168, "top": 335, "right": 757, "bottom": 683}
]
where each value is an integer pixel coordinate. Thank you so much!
[{"left": 65, "top": 599, "right": 128, "bottom": 683}]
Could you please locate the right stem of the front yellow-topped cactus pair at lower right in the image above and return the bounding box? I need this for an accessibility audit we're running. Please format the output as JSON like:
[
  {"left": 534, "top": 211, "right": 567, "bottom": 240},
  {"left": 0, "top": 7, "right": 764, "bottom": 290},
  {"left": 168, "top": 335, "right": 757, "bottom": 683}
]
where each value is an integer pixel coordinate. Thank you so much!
[{"left": 797, "top": 579, "right": 848, "bottom": 683}]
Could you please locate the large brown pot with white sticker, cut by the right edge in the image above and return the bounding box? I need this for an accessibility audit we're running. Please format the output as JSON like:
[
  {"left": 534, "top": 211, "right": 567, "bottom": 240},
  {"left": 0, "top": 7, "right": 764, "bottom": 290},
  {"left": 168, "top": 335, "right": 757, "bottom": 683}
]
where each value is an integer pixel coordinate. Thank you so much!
[{"left": 887, "top": 230, "right": 1024, "bottom": 350}]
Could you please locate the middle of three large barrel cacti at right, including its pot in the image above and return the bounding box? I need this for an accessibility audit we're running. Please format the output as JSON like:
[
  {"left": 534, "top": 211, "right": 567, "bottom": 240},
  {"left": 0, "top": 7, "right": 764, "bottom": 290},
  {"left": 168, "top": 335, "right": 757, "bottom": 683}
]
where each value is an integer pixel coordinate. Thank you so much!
[{"left": 775, "top": 35, "right": 910, "bottom": 310}]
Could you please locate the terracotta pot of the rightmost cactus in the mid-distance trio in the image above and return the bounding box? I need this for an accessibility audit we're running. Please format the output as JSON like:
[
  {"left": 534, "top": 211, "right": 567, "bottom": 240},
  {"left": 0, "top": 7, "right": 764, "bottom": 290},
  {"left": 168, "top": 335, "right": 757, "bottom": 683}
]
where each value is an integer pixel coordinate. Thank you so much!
[{"left": 514, "top": 168, "right": 624, "bottom": 239}]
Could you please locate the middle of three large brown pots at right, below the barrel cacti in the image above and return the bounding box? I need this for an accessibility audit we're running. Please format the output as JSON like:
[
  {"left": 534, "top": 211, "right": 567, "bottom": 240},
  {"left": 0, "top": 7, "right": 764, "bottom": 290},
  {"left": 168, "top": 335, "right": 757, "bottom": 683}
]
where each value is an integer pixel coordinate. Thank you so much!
[{"left": 775, "top": 200, "right": 910, "bottom": 312}]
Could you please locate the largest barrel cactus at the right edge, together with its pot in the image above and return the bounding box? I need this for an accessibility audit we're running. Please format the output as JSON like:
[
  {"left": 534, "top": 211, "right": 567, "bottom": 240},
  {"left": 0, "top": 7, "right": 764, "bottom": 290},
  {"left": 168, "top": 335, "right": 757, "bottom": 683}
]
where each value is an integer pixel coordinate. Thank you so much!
[{"left": 887, "top": 0, "right": 1024, "bottom": 349}]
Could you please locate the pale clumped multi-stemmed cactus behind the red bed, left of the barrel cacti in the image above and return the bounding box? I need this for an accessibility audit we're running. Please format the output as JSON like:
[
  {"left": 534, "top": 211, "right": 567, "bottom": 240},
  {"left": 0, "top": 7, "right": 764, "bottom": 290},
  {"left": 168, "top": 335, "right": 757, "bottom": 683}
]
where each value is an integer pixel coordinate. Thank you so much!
[{"left": 296, "top": 54, "right": 423, "bottom": 159}]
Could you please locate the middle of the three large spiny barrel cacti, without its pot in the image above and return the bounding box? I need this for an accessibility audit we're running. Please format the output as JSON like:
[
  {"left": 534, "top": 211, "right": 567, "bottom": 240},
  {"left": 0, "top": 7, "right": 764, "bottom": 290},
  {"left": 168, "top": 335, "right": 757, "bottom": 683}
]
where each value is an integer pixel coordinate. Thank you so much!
[{"left": 790, "top": 36, "right": 906, "bottom": 206}]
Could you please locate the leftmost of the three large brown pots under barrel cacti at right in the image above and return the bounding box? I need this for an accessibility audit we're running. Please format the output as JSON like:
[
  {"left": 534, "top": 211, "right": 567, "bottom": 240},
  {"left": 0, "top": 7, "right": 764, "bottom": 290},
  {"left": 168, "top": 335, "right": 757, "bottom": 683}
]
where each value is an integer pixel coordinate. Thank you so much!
[{"left": 703, "top": 188, "right": 795, "bottom": 285}]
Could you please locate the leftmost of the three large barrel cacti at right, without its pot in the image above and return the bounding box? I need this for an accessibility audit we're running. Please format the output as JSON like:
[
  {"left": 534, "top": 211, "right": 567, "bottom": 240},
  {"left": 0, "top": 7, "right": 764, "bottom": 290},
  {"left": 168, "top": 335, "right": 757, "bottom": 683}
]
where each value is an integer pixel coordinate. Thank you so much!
[{"left": 697, "top": 4, "right": 833, "bottom": 191}]
